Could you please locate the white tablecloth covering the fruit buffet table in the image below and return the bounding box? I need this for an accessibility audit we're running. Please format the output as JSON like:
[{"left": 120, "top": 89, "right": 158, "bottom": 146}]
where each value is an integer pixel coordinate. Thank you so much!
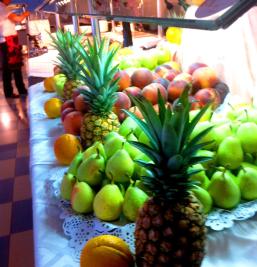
[{"left": 29, "top": 83, "right": 257, "bottom": 267}]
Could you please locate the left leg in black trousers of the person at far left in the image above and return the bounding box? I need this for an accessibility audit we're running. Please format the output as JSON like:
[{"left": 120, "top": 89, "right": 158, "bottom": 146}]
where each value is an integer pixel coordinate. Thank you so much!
[{"left": 0, "top": 43, "right": 13, "bottom": 97}]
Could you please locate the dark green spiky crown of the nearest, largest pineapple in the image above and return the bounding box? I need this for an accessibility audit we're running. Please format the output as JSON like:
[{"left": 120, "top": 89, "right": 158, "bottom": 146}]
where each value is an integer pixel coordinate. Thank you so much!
[{"left": 124, "top": 90, "right": 211, "bottom": 201}]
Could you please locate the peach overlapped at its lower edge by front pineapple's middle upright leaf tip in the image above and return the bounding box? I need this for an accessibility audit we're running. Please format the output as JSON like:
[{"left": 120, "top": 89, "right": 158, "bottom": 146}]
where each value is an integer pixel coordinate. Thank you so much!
[{"left": 142, "top": 83, "right": 167, "bottom": 105}]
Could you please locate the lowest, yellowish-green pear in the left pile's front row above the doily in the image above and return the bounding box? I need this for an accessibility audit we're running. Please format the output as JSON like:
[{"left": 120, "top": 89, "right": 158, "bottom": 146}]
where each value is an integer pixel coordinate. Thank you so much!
[{"left": 93, "top": 184, "right": 123, "bottom": 221}]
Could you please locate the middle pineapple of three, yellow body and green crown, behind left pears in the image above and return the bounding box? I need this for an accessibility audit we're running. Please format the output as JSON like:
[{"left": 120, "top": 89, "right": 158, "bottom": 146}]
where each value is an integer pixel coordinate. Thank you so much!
[{"left": 76, "top": 37, "right": 119, "bottom": 147}]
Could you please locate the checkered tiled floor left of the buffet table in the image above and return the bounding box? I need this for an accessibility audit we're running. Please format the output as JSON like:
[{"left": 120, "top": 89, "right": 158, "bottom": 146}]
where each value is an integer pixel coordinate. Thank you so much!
[{"left": 0, "top": 69, "right": 34, "bottom": 267}]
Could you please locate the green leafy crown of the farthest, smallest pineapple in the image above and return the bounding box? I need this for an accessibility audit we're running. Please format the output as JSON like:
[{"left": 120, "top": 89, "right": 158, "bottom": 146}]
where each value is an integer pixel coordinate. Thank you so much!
[{"left": 50, "top": 29, "right": 83, "bottom": 81}]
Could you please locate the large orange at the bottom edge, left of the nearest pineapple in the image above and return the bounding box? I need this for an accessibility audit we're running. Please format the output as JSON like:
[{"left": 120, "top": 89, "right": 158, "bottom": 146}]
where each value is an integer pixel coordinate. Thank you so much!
[{"left": 80, "top": 235, "right": 134, "bottom": 267}]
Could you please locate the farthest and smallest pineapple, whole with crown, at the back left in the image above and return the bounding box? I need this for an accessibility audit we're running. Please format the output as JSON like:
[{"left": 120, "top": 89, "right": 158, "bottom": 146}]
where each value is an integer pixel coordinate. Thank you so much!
[{"left": 51, "top": 30, "right": 82, "bottom": 100}]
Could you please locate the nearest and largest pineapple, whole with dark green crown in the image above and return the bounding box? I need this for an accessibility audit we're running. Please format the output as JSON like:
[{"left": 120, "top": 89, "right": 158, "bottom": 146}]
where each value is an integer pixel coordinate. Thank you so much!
[{"left": 126, "top": 91, "right": 210, "bottom": 267}]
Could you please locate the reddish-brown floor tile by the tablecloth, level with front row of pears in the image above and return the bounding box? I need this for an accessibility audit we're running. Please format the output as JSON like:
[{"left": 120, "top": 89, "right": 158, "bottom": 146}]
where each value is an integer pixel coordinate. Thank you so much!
[{"left": 13, "top": 175, "right": 31, "bottom": 201}]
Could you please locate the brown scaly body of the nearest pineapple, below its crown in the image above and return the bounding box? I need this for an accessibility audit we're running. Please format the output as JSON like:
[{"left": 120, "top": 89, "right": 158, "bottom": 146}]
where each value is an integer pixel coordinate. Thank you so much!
[{"left": 135, "top": 195, "right": 206, "bottom": 267}]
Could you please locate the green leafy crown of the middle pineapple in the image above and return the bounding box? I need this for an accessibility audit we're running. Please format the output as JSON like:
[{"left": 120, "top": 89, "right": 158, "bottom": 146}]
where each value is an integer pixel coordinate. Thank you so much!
[{"left": 73, "top": 37, "right": 119, "bottom": 115}]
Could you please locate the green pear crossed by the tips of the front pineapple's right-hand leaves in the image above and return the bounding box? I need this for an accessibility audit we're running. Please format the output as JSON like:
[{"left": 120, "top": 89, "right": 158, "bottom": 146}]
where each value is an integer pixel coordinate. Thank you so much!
[{"left": 190, "top": 121, "right": 215, "bottom": 150}]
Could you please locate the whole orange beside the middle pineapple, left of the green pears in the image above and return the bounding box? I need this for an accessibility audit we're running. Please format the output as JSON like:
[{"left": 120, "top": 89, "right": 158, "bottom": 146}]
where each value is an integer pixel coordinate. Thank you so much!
[{"left": 54, "top": 134, "right": 82, "bottom": 165}]
